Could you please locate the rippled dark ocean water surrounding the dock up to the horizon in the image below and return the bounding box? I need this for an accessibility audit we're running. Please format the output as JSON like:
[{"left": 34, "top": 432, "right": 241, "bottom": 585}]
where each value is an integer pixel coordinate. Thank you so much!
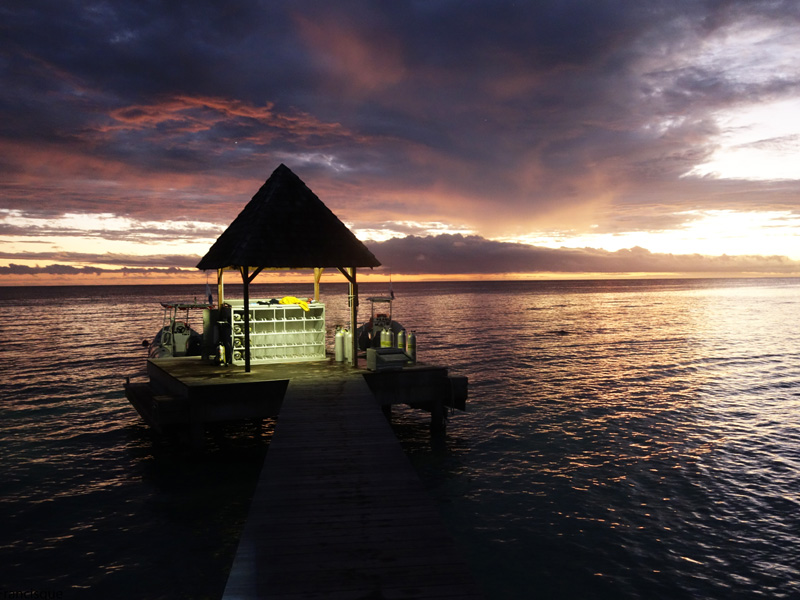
[{"left": 0, "top": 279, "right": 800, "bottom": 599}]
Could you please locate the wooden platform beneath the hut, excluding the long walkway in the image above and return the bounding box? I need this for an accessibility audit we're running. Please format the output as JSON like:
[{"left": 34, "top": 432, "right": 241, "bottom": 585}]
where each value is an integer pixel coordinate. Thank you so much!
[{"left": 125, "top": 357, "right": 467, "bottom": 448}]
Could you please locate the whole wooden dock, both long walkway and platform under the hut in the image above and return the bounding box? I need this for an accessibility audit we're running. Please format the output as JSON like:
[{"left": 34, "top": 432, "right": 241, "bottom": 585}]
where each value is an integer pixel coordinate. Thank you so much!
[{"left": 125, "top": 358, "right": 476, "bottom": 600}]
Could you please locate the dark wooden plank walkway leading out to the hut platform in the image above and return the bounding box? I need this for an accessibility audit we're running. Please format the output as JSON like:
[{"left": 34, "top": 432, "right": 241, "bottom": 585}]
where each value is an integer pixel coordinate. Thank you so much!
[{"left": 223, "top": 372, "right": 483, "bottom": 600}]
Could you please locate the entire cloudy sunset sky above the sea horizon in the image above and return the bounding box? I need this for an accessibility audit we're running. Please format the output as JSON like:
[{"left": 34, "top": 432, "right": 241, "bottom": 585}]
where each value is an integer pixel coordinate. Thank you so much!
[{"left": 0, "top": 0, "right": 800, "bottom": 285}]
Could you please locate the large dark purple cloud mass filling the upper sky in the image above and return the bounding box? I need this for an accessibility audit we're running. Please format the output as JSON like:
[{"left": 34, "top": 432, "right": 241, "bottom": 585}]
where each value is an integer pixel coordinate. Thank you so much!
[{"left": 0, "top": 0, "right": 800, "bottom": 272}]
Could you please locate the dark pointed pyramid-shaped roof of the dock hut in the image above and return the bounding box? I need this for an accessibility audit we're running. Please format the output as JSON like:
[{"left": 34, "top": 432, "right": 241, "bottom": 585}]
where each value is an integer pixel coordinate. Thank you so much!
[{"left": 197, "top": 164, "right": 381, "bottom": 269}]
